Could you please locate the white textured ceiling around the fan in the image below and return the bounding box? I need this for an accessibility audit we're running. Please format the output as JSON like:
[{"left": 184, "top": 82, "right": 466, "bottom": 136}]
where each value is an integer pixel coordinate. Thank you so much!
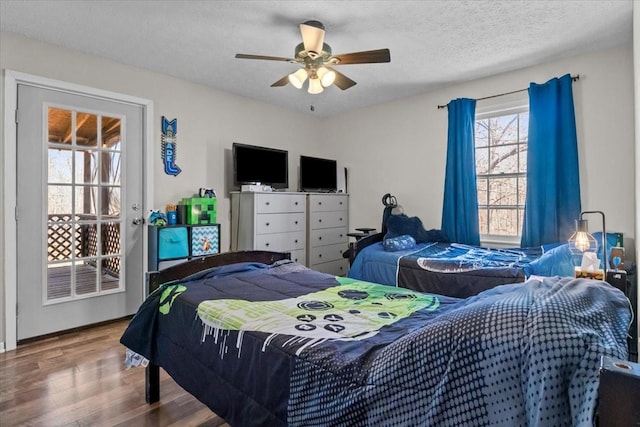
[{"left": 0, "top": 0, "right": 633, "bottom": 116}]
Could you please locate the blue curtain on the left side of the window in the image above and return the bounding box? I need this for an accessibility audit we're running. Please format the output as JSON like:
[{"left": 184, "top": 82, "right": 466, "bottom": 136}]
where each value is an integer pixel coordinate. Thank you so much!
[{"left": 441, "top": 98, "right": 480, "bottom": 245}]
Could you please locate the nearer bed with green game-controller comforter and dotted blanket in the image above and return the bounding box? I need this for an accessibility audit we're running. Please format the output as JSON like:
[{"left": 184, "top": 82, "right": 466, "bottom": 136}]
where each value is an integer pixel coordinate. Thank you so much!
[{"left": 121, "top": 252, "right": 631, "bottom": 426}]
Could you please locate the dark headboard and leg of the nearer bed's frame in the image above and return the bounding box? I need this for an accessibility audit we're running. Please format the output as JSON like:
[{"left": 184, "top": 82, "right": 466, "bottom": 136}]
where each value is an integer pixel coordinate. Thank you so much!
[{"left": 145, "top": 251, "right": 291, "bottom": 403}]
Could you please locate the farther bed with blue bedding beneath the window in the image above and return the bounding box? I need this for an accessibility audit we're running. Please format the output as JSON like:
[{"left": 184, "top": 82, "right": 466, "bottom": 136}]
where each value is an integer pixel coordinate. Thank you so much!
[{"left": 348, "top": 194, "right": 575, "bottom": 298}]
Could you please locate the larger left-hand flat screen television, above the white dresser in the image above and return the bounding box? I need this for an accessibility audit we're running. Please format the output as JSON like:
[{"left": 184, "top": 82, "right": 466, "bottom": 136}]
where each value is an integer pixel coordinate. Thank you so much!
[{"left": 232, "top": 142, "right": 289, "bottom": 189}]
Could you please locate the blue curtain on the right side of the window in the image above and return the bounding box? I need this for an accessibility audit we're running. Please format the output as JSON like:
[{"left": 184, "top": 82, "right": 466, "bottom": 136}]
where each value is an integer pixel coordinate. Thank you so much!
[{"left": 520, "top": 74, "right": 580, "bottom": 247}]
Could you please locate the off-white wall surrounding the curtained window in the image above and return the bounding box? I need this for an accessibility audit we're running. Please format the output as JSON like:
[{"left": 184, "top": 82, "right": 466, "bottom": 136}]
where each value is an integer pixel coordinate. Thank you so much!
[{"left": 323, "top": 45, "right": 636, "bottom": 258}]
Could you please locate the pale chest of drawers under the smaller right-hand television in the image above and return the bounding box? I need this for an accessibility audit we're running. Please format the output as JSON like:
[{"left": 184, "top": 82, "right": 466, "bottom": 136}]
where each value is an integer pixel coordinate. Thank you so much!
[{"left": 307, "top": 193, "right": 349, "bottom": 276}]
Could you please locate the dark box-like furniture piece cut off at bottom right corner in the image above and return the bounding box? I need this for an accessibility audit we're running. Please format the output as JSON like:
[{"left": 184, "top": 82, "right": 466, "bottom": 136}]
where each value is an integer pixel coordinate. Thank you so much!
[{"left": 597, "top": 356, "right": 640, "bottom": 427}]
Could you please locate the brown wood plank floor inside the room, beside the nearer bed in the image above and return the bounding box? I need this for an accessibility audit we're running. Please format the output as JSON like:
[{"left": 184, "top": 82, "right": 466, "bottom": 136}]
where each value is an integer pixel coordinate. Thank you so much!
[{"left": 0, "top": 320, "right": 229, "bottom": 427}]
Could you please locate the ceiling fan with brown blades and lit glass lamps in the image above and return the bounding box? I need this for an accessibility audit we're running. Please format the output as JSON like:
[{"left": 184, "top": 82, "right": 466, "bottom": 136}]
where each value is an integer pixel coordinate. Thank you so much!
[{"left": 236, "top": 21, "right": 391, "bottom": 95}]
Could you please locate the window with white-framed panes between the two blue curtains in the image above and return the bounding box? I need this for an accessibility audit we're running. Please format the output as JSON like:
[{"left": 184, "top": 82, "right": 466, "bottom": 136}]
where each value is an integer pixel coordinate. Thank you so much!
[{"left": 475, "top": 106, "right": 529, "bottom": 241}]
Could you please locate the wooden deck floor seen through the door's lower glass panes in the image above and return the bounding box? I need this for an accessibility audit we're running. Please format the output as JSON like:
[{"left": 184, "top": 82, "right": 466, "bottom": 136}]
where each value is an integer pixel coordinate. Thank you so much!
[{"left": 47, "top": 264, "right": 119, "bottom": 300}]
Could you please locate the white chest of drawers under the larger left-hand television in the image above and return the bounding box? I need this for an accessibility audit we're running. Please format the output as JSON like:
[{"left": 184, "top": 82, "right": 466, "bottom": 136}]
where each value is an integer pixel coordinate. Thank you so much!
[{"left": 231, "top": 192, "right": 307, "bottom": 264}]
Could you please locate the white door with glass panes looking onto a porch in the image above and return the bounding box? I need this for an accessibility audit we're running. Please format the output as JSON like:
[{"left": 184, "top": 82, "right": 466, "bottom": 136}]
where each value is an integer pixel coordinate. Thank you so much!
[{"left": 16, "top": 84, "right": 145, "bottom": 340}]
